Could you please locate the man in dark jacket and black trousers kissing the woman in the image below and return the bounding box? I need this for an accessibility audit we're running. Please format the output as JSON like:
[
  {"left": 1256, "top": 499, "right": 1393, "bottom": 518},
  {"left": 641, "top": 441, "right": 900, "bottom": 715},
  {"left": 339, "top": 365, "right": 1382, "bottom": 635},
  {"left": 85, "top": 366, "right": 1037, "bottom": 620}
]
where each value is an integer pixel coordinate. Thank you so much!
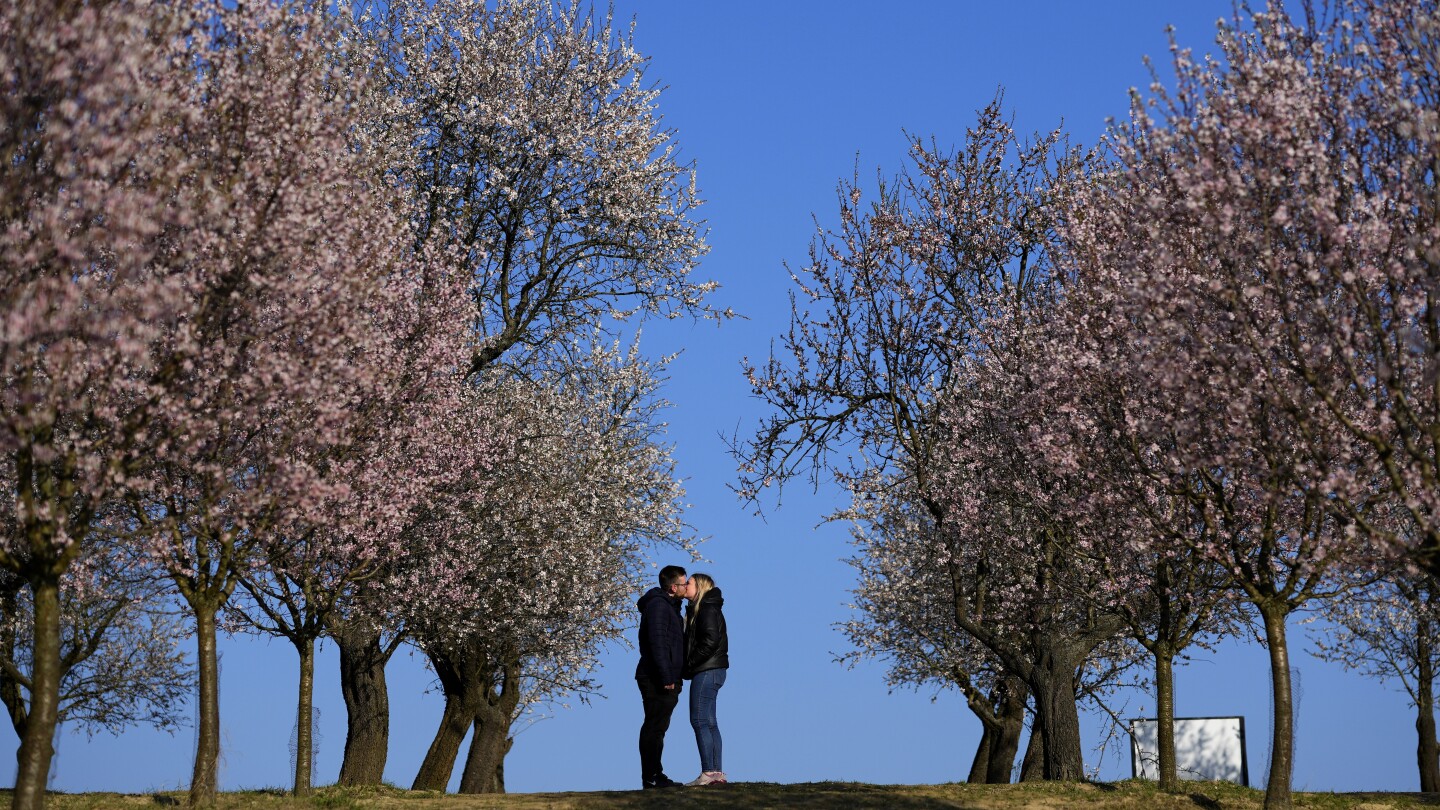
[{"left": 635, "top": 565, "right": 694, "bottom": 788}]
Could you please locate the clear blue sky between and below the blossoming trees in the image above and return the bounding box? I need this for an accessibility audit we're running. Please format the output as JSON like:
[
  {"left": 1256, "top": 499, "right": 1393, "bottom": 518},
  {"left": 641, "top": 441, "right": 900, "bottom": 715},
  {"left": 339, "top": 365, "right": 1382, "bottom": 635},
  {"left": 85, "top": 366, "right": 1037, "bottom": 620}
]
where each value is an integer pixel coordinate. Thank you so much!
[{"left": 16, "top": 0, "right": 1418, "bottom": 791}]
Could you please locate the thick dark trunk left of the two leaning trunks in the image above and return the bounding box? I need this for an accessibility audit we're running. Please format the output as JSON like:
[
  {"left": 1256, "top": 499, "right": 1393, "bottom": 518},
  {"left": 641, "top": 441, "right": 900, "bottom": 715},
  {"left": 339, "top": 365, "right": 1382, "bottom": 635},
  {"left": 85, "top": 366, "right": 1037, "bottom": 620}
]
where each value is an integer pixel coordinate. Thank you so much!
[{"left": 331, "top": 630, "right": 390, "bottom": 785}]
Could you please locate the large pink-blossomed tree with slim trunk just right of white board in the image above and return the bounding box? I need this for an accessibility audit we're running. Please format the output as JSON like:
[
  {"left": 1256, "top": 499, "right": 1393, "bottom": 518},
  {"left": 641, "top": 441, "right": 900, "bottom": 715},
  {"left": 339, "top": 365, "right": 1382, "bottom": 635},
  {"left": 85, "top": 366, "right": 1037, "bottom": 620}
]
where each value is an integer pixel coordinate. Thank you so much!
[{"left": 1073, "top": 3, "right": 1416, "bottom": 807}]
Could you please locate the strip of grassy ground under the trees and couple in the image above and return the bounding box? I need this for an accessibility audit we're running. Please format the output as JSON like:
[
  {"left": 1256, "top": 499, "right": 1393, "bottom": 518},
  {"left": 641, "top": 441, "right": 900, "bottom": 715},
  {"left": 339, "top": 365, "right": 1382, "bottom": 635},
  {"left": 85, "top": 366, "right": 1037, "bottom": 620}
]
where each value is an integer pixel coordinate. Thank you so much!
[{"left": 11, "top": 780, "right": 1440, "bottom": 810}]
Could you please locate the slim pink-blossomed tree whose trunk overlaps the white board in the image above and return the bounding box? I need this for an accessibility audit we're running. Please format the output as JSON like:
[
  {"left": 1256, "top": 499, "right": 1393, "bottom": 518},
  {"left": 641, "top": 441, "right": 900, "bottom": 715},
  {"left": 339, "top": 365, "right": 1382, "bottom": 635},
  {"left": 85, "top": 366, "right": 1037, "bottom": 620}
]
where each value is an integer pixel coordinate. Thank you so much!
[{"left": 1017, "top": 265, "right": 1247, "bottom": 791}]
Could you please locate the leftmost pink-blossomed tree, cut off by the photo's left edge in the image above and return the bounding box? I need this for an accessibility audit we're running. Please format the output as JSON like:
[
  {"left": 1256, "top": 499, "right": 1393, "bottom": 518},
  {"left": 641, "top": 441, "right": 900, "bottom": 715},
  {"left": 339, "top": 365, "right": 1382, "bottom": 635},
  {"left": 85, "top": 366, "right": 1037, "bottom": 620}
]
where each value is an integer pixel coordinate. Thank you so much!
[{"left": 0, "top": 0, "right": 210, "bottom": 809}]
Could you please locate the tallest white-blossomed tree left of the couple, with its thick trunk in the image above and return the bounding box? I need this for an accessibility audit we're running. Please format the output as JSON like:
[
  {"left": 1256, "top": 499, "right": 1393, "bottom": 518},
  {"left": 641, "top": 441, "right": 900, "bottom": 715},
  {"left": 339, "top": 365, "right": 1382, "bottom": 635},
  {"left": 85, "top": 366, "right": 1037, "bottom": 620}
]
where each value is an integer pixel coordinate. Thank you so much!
[{"left": 331, "top": 0, "right": 727, "bottom": 784}]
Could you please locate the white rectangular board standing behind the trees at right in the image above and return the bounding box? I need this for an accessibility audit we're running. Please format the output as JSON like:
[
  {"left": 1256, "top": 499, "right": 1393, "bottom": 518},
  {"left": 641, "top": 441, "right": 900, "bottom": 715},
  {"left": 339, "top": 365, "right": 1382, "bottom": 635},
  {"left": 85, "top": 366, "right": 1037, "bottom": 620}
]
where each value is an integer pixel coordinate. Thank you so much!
[{"left": 1130, "top": 718, "right": 1250, "bottom": 787}]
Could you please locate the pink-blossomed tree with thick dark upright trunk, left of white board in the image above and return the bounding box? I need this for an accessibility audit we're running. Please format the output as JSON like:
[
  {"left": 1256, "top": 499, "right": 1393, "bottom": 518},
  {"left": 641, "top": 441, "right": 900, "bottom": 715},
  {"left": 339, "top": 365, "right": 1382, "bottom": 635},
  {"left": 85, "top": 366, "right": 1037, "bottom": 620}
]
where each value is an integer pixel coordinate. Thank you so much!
[{"left": 919, "top": 304, "right": 1133, "bottom": 780}]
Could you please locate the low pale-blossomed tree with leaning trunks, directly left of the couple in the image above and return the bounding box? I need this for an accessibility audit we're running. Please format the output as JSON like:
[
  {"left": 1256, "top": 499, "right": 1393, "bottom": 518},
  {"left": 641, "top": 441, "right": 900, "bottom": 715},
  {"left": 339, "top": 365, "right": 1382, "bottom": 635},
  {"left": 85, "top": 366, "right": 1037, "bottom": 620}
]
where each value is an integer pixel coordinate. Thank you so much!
[{"left": 406, "top": 336, "right": 691, "bottom": 793}]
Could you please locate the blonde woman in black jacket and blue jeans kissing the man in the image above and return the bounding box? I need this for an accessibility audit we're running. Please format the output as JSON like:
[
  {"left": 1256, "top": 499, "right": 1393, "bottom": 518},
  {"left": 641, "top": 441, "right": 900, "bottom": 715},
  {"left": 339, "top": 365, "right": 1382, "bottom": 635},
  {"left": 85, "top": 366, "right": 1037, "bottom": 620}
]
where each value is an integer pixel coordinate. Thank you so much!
[{"left": 684, "top": 574, "right": 730, "bottom": 787}]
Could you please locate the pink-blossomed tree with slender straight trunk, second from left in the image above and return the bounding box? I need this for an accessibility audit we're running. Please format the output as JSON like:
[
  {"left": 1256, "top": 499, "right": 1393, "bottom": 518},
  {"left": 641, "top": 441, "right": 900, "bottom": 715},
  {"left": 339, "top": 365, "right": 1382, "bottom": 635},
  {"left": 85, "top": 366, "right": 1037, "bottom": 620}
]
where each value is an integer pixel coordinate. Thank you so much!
[{"left": 102, "top": 3, "right": 432, "bottom": 806}]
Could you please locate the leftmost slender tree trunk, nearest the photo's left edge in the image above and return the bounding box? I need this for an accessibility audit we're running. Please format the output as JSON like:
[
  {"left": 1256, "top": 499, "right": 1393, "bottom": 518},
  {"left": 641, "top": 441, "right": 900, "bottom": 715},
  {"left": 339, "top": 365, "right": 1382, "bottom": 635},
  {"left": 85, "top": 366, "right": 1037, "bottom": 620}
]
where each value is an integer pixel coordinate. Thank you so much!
[{"left": 10, "top": 577, "right": 60, "bottom": 810}]
